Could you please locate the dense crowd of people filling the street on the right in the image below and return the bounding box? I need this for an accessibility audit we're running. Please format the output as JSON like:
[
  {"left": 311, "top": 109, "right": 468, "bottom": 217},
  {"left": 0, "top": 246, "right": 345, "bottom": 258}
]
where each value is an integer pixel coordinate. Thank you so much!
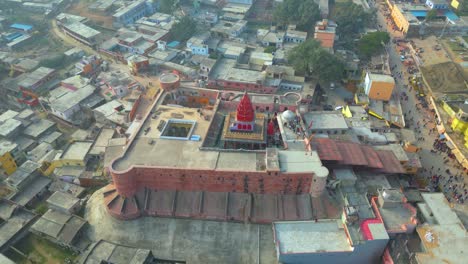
[{"left": 385, "top": 4, "right": 468, "bottom": 204}]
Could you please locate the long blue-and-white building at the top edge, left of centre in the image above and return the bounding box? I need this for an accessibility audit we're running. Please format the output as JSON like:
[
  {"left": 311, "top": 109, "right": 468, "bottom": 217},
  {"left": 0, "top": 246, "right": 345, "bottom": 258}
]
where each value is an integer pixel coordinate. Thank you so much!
[{"left": 112, "top": 0, "right": 155, "bottom": 27}]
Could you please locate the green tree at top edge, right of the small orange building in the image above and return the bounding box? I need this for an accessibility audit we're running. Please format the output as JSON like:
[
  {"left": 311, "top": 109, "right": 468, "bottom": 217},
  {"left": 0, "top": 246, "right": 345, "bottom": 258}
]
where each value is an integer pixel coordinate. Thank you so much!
[{"left": 335, "top": 1, "right": 374, "bottom": 44}]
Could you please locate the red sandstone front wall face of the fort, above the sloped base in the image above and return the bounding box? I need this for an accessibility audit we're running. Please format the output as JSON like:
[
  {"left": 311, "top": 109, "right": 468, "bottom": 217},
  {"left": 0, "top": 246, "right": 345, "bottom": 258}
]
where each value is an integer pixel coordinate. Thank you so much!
[{"left": 111, "top": 167, "right": 313, "bottom": 196}]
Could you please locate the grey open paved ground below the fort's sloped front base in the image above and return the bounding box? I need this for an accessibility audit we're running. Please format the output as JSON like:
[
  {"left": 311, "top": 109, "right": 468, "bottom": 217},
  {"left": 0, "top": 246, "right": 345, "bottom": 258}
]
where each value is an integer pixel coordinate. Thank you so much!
[{"left": 85, "top": 190, "right": 275, "bottom": 264}]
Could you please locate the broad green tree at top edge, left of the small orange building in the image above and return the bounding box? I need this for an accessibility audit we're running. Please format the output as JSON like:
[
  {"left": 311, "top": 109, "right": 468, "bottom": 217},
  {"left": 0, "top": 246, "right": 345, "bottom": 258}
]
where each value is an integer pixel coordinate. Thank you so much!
[{"left": 273, "top": 0, "right": 320, "bottom": 31}]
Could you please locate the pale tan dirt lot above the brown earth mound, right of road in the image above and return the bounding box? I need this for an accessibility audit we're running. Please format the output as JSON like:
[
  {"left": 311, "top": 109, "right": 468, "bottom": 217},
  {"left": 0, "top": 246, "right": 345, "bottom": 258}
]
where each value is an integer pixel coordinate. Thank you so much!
[{"left": 411, "top": 36, "right": 451, "bottom": 67}]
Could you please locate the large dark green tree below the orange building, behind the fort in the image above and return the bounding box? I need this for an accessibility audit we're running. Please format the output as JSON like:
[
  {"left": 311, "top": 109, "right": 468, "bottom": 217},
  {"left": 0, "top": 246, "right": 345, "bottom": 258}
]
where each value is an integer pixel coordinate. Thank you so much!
[{"left": 288, "top": 39, "right": 344, "bottom": 82}]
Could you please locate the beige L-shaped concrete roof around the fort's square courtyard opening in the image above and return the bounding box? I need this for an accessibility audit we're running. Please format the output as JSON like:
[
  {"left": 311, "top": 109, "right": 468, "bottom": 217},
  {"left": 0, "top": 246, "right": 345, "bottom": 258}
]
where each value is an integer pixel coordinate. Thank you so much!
[{"left": 113, "top": 106, "right": 264, "bottom": 171}]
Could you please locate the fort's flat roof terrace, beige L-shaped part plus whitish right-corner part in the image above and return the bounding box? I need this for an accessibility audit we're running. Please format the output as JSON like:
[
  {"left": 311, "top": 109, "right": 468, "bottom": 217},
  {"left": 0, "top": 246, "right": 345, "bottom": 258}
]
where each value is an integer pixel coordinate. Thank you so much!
[{"left": 112, "top": 90, "right": 328, "bottom": 174}]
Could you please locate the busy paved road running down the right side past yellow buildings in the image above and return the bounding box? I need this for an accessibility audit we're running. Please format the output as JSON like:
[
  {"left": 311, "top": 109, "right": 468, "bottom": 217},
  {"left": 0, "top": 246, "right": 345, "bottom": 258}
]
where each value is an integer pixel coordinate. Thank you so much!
[{"left": 378, "top": 1, "right": 468, "bottom": 206}]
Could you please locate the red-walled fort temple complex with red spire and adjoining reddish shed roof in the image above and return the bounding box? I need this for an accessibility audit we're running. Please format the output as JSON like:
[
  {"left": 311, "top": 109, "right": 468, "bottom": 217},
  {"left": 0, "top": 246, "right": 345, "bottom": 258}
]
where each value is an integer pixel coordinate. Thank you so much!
[{"left": 104, "top": 83, "right": 403, "bottom": 223}]
